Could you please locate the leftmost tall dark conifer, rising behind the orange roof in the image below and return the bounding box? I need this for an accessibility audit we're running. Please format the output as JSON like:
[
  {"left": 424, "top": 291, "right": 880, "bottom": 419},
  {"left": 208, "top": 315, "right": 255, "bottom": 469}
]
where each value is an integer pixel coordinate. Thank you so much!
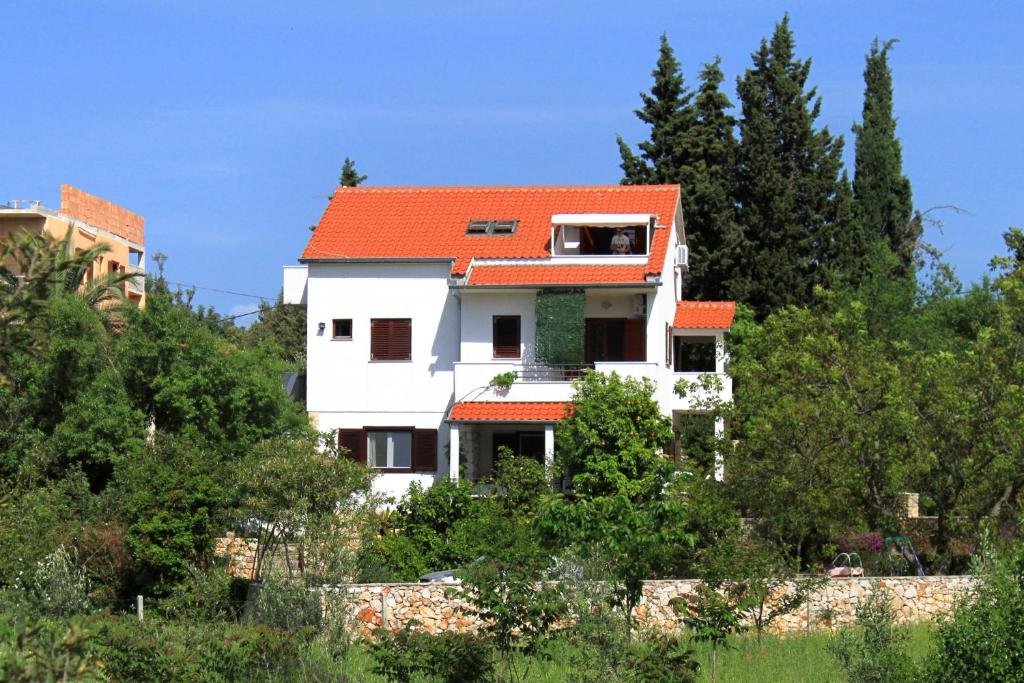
[{"left": 615, "top": 34, "right": 693, "bottom": 185}]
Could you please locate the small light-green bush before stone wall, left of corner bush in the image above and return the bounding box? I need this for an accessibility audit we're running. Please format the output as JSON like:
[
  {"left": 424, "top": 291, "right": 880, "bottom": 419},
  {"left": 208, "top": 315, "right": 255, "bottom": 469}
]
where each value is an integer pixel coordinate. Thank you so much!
[{"left": 828, "top": 588, "right": 917, "bottom": 683}]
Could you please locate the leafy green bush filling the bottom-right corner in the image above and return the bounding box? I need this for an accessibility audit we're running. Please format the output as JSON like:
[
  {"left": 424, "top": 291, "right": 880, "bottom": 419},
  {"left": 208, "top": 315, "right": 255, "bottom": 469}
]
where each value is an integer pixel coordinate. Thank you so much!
[{"left": 927, "top": 540, "right": 1024, "bottom": 683}]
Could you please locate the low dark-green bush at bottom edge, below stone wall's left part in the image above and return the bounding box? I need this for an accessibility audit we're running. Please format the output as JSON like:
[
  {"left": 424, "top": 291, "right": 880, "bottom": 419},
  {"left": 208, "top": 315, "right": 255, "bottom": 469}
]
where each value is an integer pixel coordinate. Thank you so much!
[{"left": 370, "top": 626, "right": 494, "bottom": 683}]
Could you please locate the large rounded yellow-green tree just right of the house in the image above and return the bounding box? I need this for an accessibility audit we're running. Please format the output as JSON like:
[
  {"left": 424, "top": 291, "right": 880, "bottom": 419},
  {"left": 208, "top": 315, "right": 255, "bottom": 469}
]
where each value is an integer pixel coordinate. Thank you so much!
[{"left": 677, "top": 304, "right": 913, "bottom": 561}]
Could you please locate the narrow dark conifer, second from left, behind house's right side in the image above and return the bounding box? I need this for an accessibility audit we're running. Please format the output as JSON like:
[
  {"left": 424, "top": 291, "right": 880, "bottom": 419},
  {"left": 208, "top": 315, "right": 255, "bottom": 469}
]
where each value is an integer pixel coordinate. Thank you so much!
[{"left": 680, "top": 58, "right": 738, "bottom": 300}]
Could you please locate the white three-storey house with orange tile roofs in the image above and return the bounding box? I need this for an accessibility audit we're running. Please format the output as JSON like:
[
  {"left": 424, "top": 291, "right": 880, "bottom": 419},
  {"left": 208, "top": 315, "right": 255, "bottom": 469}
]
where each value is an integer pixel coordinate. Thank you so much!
[{"left": 284, "top": 185, "right": 734, "bottom": 496}]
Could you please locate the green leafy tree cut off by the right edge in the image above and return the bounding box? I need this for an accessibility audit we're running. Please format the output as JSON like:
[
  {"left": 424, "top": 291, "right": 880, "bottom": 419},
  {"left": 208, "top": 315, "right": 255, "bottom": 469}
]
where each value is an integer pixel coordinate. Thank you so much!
[{"left": 907, "top": 229, "right": 1024, "bottom": 571}]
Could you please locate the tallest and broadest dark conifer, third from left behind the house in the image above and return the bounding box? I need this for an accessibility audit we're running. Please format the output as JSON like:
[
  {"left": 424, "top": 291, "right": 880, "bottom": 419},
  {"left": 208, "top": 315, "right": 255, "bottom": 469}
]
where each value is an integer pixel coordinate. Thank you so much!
[{"left": 729, "top": 15, "right": 853, "bottom": 317}]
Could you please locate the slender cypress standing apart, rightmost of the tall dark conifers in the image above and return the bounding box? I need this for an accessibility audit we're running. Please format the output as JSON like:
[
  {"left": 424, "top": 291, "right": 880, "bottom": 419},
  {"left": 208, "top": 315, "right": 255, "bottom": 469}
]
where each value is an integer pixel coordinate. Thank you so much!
[{"left": 853, "top": 38, "right": 922, "bottom": 279}]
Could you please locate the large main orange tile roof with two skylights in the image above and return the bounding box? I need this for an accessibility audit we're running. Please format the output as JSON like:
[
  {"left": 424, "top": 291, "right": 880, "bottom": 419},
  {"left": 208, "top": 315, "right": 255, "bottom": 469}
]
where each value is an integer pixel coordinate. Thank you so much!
[{"left": 302, "top": 185, "right": 679, "bottom": 275}]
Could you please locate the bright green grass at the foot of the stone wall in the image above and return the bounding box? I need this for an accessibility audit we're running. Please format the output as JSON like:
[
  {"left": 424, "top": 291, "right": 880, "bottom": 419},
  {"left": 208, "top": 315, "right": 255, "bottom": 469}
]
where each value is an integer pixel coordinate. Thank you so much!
[{"left": 335, "top": 625, "right": 933, "bottom": 683}]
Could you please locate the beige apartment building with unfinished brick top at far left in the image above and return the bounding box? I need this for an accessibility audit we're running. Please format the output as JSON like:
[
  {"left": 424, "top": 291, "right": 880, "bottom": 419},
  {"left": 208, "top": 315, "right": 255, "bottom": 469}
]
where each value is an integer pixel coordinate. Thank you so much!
[{"left": 0, "top": 184, "right": 145, "bottom": 306}]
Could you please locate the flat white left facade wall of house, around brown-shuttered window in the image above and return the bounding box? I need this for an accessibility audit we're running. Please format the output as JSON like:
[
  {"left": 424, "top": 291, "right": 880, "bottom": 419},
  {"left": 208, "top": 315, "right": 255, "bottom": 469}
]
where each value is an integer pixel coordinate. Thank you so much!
[{"left": 306, "top": 263, "right": 460, "bottom": 496}]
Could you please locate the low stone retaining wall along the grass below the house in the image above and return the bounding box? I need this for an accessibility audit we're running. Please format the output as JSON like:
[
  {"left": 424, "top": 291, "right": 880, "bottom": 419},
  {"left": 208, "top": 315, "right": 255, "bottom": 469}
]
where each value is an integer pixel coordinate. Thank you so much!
[{"left": 329, "top": 577, "right": 976, "bottom": 636}]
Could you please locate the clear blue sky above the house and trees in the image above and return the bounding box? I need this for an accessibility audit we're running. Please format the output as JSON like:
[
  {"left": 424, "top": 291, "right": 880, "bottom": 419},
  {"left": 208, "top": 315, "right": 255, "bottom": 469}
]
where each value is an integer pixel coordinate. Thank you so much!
[{"left": 0, "top": 0, "right": 1024, "bottom": 319}]
